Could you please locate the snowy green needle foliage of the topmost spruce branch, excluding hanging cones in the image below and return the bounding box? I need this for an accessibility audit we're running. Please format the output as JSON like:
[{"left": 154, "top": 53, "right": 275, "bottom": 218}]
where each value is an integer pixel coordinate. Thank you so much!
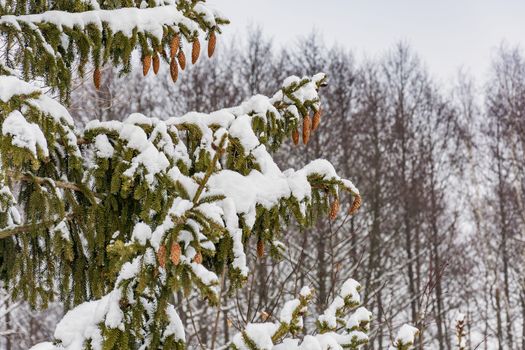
[{"left": 0, "top": 0, "right": 228, "bottom": 101}]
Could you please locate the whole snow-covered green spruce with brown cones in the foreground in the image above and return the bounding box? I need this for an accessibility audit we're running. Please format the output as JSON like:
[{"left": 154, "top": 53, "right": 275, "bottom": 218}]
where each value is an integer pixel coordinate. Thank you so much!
[{"left": 0, "top": 0, "right": 418, "bottom": 350}]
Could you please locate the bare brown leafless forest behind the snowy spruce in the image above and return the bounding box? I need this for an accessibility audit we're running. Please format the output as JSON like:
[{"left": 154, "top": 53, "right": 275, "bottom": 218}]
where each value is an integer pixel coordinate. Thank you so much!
[{"left": 0, "top": 29, "right": 525, "bottom": 350}]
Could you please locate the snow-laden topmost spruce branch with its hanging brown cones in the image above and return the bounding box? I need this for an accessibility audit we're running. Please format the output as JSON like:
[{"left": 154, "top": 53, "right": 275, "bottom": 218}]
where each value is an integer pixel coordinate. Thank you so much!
[{"left": 0, "top": 1, "right": 228, "bottom": 100}]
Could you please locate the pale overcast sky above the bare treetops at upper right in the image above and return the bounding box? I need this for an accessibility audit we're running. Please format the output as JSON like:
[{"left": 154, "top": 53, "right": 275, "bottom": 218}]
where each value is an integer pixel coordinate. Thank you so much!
[{"left": 208, "top": 0, "right": 525, "bottom": 81}]
